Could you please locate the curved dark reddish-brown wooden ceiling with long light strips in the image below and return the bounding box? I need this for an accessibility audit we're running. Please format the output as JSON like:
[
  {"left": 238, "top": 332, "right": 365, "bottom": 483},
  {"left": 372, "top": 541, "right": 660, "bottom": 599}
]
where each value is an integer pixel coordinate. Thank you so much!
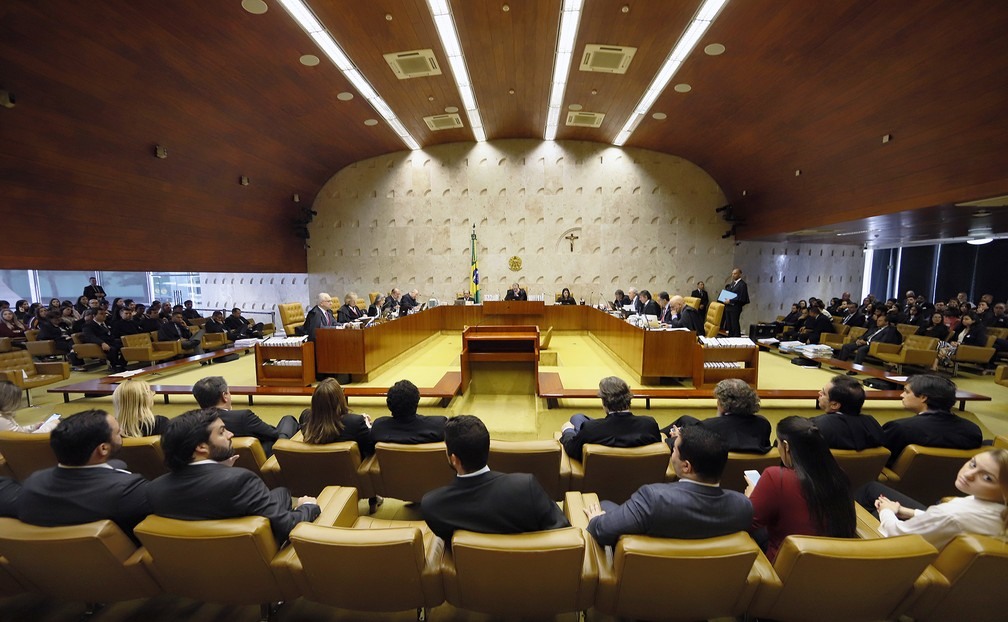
[{"left": 0, "top": 0, "right": 1008, "bottom": 271}]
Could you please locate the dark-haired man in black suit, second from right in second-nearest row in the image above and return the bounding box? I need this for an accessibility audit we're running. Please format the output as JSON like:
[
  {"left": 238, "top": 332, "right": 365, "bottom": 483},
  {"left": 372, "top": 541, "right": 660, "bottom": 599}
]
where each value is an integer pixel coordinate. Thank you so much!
[{"left": 811, "top": 376, "right": 882, "bottom": 452}]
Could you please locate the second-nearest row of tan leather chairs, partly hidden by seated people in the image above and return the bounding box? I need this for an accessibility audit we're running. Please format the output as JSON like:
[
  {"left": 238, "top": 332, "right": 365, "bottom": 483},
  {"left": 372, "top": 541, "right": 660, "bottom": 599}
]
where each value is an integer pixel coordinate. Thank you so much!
[{"left": 0, "top": 432, "right": 987, "bottom": 504}]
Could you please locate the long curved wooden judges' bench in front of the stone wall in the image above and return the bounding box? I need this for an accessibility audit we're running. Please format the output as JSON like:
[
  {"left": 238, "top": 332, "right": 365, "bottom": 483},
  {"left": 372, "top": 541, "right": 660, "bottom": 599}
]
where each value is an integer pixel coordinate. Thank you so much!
[{"left": 316, "top": 300, "right": 697, "bottom": 383}]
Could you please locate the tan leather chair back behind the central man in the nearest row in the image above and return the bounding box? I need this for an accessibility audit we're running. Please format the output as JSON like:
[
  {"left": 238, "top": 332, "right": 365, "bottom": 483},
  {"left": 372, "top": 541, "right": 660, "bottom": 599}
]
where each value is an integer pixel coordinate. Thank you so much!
[{"left": 442, "top": 527, "right": 599, "bottom": 617}]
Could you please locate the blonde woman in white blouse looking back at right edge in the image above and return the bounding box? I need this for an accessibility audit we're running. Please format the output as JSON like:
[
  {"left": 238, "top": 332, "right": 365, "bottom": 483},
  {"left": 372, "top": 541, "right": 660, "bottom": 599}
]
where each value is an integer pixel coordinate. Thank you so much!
[{"left": 857, "top": 449, "right": 1008, "bottom": 548}]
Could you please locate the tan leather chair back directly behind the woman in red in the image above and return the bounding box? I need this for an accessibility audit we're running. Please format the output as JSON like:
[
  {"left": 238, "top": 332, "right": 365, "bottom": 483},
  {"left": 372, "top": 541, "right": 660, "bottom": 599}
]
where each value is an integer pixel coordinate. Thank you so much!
[{"left": 749, "top": 535, "right": 937, "bottom": 622}]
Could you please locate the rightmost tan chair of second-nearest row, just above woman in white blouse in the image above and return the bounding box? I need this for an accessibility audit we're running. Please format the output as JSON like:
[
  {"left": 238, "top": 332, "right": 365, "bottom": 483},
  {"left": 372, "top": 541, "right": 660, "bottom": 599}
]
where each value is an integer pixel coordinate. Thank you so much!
[{"left": 883, "top": 445, "right": 987, "bottom": 505}]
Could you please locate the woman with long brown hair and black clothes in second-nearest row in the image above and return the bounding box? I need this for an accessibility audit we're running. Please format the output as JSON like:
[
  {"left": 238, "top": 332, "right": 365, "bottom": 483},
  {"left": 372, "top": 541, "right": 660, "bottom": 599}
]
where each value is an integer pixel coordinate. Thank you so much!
[{"left": 299, "top": 378, "right": 383, "bottom": 513}]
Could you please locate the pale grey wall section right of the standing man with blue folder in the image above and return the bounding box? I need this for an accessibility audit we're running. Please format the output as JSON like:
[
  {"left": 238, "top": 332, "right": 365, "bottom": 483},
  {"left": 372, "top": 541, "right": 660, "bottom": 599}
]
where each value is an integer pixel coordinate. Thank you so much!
[{"left": 735, "top": 242, "right": 865, "bottom": 328}]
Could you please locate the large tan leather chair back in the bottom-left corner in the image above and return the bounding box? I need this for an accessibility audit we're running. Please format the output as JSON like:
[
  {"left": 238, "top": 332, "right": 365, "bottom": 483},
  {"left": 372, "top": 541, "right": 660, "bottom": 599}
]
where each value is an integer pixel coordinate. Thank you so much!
[{"left": 0, "top": 518, "right": 161, "bottom": 603}]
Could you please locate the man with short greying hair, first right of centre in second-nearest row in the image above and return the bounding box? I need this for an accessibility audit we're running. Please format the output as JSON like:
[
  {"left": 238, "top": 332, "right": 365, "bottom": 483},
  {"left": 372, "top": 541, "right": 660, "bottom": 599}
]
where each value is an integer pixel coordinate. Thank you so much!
[{"left": 560, "top": 376, "right": 661, "bottom": 460}]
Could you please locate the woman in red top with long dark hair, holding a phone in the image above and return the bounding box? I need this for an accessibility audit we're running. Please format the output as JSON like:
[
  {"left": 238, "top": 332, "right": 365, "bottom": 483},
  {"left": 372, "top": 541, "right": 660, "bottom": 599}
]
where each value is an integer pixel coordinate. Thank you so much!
[{"left": 746, "top": 415, "right": 856, "bottom": 562}]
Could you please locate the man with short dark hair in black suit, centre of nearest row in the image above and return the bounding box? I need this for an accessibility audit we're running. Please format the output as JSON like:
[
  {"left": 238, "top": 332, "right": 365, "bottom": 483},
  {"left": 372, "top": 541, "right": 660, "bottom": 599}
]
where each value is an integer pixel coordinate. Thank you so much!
[{"left": 420, "top": 414, "right": 570, "bottom": 546}]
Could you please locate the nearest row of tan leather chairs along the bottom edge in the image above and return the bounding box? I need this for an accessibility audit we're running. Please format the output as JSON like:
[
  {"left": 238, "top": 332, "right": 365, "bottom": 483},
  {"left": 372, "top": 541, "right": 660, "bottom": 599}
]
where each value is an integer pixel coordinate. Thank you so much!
[{"left": 0, "top": 487, "right": 1008, "bottom": 621}]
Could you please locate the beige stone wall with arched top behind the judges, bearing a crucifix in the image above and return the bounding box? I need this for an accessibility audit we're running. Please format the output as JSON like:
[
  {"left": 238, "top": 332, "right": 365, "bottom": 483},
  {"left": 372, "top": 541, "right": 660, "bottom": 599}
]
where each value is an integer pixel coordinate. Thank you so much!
[{"left": 307, "top": 140, "right": 735, "bottom": 300}]
